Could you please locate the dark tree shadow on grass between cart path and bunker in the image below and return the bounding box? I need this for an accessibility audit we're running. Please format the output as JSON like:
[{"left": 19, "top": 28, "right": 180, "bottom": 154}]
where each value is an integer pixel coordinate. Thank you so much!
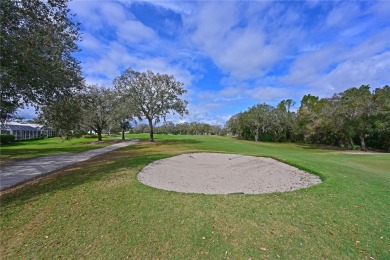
[{"left": 0, "top": 151, "right": 169, "bottom": 208}]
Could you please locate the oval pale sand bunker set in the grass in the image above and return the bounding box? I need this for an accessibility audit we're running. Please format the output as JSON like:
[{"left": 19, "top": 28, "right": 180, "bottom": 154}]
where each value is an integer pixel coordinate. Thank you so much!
[{"left": 138, "top": 153, "right": 321, "bottom": 194}]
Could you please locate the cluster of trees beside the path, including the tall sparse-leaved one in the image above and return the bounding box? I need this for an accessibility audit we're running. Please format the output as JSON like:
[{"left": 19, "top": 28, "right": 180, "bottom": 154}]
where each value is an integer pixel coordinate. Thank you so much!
[{"left": 40, "top": 69, "right": 188, "bottom": 142}]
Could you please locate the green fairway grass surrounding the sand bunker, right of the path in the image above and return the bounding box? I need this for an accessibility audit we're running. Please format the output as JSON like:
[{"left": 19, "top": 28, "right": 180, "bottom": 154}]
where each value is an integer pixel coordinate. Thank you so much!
[{"left": 0, "top": 135, "right": 390, "bottom": 259}]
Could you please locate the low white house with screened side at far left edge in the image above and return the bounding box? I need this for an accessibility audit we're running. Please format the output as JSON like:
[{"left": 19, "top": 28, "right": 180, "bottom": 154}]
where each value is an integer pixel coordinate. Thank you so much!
[{"left": 0, "top": 122, "right": 53, "bottom": 140}]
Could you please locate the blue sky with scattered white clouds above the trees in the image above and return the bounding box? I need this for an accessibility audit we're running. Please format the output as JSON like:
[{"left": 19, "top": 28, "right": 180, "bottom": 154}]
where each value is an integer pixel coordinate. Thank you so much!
[{"left": 20, "top": 1, "right": 390, "bottom": 124}]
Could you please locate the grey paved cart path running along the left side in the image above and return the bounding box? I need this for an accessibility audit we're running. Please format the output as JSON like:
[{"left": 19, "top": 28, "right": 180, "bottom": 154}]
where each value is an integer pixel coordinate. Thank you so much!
[{"left": 0, "top": 140, "right": 137, "bottom": 190}]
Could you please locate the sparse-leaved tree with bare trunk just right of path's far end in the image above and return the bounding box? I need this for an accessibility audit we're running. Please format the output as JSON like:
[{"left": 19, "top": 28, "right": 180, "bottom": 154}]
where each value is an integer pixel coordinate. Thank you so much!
[{"left": 114, "top": 68, "right": 188, "bottom": 142}]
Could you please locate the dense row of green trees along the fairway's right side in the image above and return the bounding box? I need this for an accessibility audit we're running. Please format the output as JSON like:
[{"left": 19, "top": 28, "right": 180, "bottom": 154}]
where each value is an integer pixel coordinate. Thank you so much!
[{"left": 227, "top": 85, "right": 390, "bottom": 150}]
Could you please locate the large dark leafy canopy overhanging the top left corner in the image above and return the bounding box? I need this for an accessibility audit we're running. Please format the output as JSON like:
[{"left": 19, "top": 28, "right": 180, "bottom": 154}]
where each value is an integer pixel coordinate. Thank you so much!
[{"left": 0, "top": 0, "right": 82, "bottom": 118}]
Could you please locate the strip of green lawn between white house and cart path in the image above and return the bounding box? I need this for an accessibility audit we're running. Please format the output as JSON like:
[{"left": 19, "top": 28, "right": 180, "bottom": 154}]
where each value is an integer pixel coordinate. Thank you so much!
[{"left": 0, "top": 136, "right": 119, "bottom": 164}]
